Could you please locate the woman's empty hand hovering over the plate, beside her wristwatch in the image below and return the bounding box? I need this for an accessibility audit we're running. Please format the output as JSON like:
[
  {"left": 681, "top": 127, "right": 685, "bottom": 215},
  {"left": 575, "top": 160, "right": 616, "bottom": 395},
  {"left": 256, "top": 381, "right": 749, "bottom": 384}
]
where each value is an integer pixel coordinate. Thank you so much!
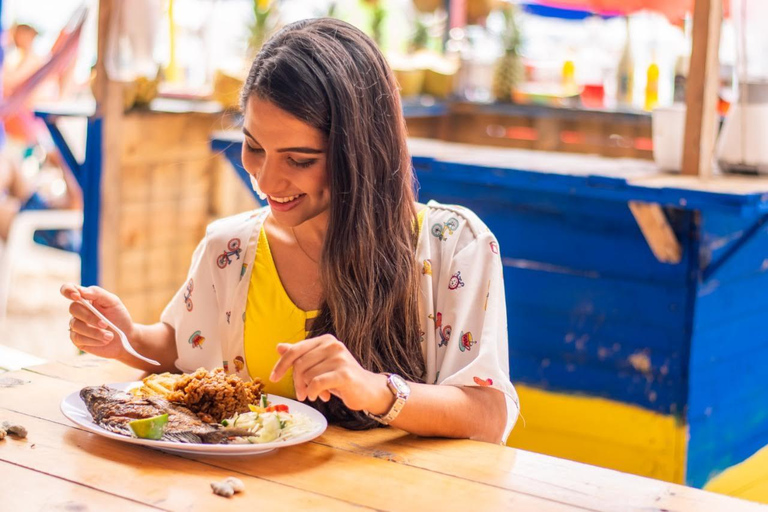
[{"left": 269, "top": 334, "right": 392, "bottom": 411}]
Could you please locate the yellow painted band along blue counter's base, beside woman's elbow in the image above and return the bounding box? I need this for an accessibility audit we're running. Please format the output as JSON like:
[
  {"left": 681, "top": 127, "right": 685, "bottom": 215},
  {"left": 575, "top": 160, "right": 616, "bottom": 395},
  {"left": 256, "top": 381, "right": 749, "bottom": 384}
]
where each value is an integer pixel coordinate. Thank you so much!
[{"left": 507, "top": 384, "right": 687, "bottom": 483}]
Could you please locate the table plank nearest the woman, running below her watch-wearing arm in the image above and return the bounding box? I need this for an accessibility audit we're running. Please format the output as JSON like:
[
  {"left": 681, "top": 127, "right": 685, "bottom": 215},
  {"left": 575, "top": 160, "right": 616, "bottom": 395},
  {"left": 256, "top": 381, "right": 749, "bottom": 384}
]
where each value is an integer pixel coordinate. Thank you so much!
[{"left": 317, "top": 429, "right": 753, "bottom": 512}]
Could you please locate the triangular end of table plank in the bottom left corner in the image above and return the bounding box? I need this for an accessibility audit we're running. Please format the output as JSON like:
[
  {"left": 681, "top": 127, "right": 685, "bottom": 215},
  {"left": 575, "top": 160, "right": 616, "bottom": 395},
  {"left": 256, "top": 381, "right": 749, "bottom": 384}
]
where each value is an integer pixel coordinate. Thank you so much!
[{"left": 0, "top": 461, "right": 163, "bottom": 512}]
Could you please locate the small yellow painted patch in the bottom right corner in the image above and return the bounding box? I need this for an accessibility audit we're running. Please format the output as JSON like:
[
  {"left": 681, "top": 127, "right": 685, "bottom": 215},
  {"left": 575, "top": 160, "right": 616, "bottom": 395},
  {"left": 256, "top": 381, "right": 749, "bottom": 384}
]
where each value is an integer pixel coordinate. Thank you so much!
[{"left": 704, "top": 446, "right": 768, "bottom": 503}]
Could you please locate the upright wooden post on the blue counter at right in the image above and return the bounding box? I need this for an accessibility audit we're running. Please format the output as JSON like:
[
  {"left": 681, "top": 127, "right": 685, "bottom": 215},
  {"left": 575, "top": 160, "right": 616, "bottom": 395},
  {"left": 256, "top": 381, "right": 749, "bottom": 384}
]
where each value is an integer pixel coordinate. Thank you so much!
[{"left": 682, "top": 0, "right": 723, "bottom": 178}]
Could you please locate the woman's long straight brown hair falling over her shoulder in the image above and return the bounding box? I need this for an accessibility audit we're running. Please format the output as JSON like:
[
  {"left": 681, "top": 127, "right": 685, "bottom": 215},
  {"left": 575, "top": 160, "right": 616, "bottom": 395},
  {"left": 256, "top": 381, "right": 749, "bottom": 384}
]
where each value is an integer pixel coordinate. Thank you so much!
[{"left": 241, "top": 18, "right": 425, "bottom": 429}]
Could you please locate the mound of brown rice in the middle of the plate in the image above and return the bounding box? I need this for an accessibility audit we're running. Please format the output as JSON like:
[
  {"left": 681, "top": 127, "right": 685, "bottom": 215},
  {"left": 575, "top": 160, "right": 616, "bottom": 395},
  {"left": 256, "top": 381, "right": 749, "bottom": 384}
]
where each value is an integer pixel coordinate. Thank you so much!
[{"left": 166, "top": 368, "right": 262, "bottom": 423}]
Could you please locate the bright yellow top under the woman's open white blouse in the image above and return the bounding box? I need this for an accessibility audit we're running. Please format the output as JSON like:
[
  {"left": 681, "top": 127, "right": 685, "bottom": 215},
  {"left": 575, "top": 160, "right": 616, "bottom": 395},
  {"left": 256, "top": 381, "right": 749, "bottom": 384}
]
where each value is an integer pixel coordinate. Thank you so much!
[{"left": 243, "top": 208, "right": 427, "bottom": 399}]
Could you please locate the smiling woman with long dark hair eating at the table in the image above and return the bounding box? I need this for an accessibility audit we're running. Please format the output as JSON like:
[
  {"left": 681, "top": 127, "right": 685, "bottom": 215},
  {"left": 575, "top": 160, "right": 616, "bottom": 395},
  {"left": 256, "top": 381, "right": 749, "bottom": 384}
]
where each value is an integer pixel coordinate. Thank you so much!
[{"left": 63, "top": 19, "right": 518, "bottom": 443}]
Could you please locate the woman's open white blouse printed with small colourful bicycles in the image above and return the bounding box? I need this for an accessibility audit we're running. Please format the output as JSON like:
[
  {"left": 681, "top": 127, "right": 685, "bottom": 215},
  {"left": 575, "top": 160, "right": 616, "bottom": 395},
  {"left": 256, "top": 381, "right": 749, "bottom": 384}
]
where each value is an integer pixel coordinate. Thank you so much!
[{"left": 161, "top": 201, "right": 520, "bottom": 440}]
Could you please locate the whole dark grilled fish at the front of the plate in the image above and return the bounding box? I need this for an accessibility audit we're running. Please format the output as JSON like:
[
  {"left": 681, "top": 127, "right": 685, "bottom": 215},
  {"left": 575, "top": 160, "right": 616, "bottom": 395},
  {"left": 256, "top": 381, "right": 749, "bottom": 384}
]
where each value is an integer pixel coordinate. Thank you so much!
[{"left": 80, "top": 386, "right": 253, "bottom": 444}]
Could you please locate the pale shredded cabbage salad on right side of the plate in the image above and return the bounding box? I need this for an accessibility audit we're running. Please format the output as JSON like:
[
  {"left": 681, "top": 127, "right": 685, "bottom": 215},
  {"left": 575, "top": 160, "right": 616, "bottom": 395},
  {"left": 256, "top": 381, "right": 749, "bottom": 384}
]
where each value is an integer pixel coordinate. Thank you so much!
[{"left": 221, "top": 395, "right": 316, "bottom": 444}]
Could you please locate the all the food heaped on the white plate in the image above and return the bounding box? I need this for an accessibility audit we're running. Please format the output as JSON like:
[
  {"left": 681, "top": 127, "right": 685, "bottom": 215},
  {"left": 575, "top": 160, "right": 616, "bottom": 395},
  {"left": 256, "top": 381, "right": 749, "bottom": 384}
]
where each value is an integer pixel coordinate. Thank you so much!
[{"left": 80, "top": 368, "right": 317, "bottom": 444}]
